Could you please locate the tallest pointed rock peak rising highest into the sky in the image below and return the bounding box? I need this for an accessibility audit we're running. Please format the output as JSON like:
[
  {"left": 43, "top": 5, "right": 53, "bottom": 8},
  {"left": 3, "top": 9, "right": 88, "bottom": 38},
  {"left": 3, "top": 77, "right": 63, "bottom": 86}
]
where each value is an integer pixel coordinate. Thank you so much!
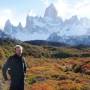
[{"left": 44, "top": 4, "right": 57, "bottom": 18}]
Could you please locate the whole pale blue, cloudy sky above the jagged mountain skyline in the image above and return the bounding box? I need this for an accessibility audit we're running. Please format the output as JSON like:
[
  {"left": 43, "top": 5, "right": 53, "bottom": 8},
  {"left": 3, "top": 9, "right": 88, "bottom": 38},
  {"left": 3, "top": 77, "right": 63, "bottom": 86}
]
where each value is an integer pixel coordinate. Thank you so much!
[{"left": 0, "top": 0, "right": 90, "bottom": 28}]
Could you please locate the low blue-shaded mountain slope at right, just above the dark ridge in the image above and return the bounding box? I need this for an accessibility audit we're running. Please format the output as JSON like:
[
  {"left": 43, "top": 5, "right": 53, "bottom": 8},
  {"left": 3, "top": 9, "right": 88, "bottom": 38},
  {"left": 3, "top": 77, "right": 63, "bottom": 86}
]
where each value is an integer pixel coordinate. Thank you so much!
[{"left": 47, "top": 33, "right": 90, "bottom": 46}]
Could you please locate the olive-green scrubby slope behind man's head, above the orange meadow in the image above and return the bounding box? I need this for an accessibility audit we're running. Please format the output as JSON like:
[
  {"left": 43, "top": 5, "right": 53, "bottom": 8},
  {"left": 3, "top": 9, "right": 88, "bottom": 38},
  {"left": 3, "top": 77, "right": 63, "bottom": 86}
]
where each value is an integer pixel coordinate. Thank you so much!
[{"left": 0, "top": 40, "right": 90, "bottom": 58}]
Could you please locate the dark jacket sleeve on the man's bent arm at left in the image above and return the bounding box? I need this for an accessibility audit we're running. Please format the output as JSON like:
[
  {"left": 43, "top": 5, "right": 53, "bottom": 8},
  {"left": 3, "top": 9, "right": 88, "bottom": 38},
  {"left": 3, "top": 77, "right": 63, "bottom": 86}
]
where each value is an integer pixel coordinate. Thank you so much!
[{"left": 2, "top": 58, "right": 11, "bottom": 80}]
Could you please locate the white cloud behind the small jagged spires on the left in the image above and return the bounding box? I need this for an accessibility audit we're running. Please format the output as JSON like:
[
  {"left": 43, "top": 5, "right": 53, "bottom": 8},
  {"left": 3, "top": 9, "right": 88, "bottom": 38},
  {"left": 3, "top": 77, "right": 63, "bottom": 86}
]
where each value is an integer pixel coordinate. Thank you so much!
[{"left": 0, "top": 9, "right": 27, "bottom": 29}]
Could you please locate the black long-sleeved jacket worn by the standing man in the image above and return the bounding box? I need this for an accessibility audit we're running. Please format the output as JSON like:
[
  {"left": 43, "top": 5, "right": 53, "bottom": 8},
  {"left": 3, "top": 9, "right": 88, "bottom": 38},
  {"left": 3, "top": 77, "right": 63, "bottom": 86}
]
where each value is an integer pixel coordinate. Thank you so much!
[{"left": 2, "top": 54, "right": 26, "bottom": 87}]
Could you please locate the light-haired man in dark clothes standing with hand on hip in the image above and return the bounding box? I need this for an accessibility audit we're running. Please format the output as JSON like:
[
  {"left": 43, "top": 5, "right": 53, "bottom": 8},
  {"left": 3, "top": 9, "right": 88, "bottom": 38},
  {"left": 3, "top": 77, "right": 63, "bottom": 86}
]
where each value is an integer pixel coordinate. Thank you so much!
[{"left": 2, "top": 45, "right": 26, "bottom": 90}]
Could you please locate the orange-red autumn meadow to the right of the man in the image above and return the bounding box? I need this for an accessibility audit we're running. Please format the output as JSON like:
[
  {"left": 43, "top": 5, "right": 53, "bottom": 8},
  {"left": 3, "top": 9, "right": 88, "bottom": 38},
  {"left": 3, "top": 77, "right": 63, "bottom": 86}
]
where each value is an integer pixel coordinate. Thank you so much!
[{"left": 26, "top": 57, "right": 90, "bottom": 90}]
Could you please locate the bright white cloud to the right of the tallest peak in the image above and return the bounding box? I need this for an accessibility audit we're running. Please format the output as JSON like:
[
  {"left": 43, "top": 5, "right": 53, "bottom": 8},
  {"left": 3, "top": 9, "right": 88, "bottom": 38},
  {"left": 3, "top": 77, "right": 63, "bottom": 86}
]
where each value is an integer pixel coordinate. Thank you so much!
[{"left": 55, "top": 0, "right": 90, "bottom": 19}]
